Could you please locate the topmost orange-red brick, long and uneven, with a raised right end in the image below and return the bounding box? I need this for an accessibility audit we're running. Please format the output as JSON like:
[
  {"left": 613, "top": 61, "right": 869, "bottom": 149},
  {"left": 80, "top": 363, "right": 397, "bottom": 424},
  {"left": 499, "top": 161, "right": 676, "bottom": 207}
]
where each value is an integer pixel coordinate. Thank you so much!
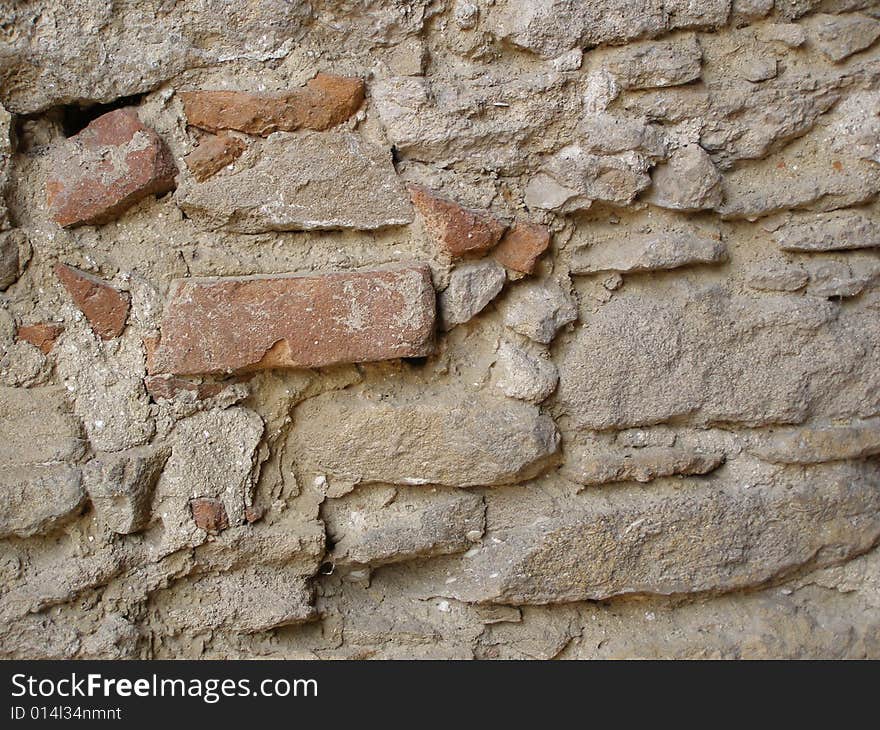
[{"left": 180, "top": 74, "right": 364, "bottom": 137}]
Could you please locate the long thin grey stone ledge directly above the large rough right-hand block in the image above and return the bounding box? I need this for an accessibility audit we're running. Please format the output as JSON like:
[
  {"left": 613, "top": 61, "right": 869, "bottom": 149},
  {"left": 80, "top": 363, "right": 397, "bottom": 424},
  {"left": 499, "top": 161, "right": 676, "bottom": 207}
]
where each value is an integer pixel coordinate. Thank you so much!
[{"left": 571, "top": 231, "right": 727, "bottom": 274}]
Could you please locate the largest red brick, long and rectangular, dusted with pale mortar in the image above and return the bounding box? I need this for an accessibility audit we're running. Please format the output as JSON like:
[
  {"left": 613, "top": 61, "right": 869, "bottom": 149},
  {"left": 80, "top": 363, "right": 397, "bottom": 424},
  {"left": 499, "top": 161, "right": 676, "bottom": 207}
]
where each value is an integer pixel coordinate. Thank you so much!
[{"left": 147, "top": 265, "right": 435, "bottom": 375}]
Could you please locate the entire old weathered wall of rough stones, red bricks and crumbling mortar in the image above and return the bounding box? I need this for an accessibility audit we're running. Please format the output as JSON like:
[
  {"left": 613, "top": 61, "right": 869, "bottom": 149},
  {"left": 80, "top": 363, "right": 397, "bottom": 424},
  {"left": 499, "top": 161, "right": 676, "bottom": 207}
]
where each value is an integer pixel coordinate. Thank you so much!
[{"left": 0, "top": 0, "right": 880, "bottom": 658}]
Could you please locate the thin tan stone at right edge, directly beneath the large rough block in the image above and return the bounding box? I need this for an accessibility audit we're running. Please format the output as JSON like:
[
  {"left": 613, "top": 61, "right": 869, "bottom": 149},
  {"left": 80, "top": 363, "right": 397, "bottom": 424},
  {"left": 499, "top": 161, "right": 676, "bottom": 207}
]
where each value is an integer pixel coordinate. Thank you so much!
[{"left": 754, "top": 421, "right": 880, "bottom": 464}]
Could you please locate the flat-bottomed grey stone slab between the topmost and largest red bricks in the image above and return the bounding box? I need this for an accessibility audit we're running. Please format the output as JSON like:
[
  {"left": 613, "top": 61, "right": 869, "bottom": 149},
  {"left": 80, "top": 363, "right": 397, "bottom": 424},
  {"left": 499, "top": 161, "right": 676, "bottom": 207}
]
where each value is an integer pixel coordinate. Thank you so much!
[{"left": 176, "top": 130, "right": 413, "bottom": 233}]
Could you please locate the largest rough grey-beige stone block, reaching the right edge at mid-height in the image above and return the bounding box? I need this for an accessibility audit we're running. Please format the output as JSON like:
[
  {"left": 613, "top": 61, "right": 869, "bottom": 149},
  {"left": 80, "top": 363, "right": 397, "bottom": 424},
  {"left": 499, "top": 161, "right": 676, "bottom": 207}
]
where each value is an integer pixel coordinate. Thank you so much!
[{"left": 559, "top": 287, "right": 880, "bottom": 429}]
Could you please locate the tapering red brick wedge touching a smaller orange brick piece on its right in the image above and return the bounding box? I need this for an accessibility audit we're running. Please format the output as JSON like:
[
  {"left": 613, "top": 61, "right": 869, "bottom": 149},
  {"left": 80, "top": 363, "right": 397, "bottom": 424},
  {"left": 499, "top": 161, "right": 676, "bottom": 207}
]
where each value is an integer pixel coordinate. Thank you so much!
[{"left": 410, "top": 185, "right": 507, "bottom": 257}]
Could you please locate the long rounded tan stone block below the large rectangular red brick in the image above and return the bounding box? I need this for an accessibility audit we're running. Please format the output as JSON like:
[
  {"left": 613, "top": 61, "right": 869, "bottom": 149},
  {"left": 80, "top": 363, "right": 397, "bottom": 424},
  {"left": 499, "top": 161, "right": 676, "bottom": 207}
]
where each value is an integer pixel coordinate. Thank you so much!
[{"left": 287, "top": 390, "right": 559, "bottom": 487}]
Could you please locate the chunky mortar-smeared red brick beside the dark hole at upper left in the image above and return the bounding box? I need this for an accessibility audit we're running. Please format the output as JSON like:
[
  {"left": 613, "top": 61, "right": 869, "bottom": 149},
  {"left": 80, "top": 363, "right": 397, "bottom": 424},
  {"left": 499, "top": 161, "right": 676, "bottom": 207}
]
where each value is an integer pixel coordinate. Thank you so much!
[{"left": 46, "top": 109, "right": 177, "bottom": 228}]
